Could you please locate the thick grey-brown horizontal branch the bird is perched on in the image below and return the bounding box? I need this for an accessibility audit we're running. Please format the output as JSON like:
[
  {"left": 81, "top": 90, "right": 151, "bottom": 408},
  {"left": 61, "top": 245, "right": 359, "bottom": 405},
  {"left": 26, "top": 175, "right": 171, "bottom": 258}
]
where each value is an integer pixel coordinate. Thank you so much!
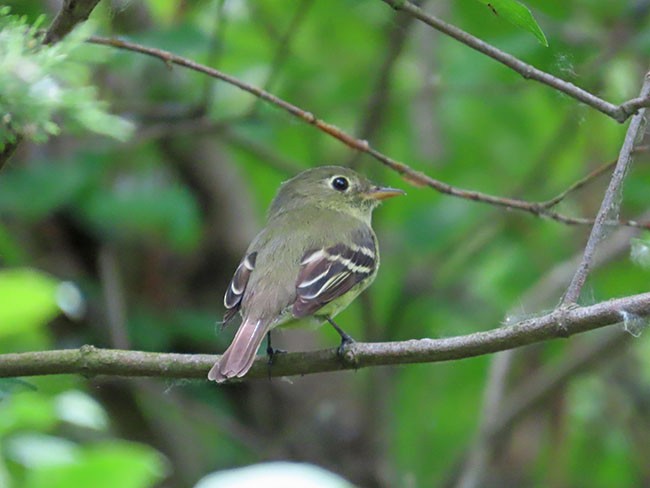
[{"left": 0, "top": 293, "right": 650, "bottom": 379}]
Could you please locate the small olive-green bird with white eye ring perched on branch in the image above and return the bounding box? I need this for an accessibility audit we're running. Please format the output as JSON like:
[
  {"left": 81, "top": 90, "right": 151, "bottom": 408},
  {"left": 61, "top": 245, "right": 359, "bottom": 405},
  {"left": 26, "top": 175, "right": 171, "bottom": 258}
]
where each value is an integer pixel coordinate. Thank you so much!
[{"left": 208, "top": 166, "right": 404, "bottom": 383}]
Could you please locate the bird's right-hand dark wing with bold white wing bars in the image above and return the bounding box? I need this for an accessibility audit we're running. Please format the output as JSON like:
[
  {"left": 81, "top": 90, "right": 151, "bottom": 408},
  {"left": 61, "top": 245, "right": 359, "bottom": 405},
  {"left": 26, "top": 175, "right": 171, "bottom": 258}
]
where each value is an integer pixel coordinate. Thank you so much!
[{"left": 292, "top": 231, "right": 378, "bottom": 318}]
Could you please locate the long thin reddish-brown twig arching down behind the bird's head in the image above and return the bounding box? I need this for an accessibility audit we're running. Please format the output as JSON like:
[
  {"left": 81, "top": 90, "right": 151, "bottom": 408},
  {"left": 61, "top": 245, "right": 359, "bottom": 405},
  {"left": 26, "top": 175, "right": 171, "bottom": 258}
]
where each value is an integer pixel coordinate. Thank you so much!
[{"left": 88, "top": 36, "right": 650, "bottom": 229}]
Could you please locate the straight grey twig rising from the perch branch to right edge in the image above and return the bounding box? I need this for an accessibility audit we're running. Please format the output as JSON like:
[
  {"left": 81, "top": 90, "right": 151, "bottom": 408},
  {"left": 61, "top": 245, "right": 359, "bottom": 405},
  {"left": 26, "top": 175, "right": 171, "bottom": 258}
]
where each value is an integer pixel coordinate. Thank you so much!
[{"left": 562, "top": 73, "right": 650, "bottom": 305}]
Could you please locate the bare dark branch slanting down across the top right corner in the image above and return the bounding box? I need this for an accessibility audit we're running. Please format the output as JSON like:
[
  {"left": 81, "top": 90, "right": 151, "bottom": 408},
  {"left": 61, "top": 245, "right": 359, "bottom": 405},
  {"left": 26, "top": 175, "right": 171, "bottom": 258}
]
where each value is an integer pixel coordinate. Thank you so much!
[{"left": 382, "top": 0, "right": 650, "bottom": 123}]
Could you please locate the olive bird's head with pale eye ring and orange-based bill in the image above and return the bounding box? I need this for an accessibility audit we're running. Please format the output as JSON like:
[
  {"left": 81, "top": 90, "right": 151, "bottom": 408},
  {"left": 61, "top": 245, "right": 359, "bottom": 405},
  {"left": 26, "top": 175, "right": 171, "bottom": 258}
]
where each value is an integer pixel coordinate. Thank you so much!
[{"left": 269, "top": 166, "right": 405, "bottom": 220}]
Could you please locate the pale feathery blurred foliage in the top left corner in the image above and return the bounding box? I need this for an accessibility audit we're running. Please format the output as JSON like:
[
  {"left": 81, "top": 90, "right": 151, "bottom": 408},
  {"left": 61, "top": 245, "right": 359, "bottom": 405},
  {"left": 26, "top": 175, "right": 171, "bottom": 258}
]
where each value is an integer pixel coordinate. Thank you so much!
[{"left": 0, "top": 7, "right": 132, "bottom": 149}]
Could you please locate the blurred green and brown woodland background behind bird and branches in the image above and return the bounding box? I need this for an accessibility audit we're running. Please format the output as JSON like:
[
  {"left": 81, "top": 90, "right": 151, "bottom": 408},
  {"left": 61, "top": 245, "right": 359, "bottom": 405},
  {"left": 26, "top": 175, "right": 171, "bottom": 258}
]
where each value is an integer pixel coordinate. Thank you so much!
[{"left": 0, "top": 0, "right": 650, "bottom": 488}]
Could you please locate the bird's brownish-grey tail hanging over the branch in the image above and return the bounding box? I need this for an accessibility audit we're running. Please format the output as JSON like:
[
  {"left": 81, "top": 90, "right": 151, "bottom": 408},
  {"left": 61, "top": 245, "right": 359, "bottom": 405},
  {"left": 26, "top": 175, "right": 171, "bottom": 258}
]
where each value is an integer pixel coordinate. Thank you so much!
[{"left": 208, "top": 319, "right": 268, "bottom": 383}]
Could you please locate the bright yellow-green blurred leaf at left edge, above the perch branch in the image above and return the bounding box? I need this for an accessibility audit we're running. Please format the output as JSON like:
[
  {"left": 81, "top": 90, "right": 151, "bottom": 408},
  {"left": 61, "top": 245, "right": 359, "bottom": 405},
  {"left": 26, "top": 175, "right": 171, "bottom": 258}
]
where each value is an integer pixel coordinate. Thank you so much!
[{"left": 0, "top": 268, "right": 59, "bottom": 337}]
